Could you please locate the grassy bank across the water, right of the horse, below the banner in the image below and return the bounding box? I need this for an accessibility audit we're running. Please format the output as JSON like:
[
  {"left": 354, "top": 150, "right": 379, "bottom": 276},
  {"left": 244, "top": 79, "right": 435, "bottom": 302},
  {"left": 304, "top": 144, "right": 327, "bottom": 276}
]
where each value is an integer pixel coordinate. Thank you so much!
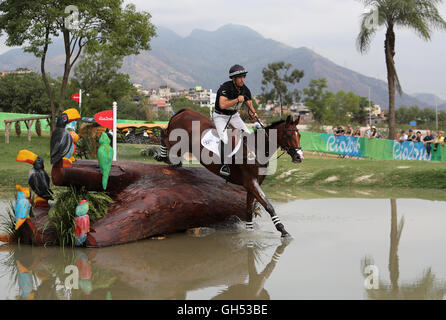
[{"left": 264, "top": 151, "right": 446, "bottom": 189}]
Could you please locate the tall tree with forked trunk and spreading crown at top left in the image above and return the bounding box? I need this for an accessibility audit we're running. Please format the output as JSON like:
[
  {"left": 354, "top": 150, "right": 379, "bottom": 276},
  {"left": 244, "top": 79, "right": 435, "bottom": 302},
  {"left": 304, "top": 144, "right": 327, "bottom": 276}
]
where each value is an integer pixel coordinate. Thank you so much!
[{"left": 0, "top": 0, "right": 155, "bottom": 130}]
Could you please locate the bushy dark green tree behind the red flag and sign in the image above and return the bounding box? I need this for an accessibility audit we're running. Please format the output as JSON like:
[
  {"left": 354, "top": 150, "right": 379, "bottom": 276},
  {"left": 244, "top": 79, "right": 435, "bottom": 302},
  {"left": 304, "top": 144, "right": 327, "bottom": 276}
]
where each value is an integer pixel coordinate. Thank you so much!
[{"left": 71, "top": 50, "right": 136, "bottom": 116}]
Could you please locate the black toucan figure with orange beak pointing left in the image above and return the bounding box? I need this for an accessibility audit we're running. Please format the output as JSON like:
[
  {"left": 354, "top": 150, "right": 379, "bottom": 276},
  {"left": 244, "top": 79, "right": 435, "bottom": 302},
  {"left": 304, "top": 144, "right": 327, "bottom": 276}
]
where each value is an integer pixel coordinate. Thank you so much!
[{"left": 16, "top": 150, "right": 53, "bottom": 207}]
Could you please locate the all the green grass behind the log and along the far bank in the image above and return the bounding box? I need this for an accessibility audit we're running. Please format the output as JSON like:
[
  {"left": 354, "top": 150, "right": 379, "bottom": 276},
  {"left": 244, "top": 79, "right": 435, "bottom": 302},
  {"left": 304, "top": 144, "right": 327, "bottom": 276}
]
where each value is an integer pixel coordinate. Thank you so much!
[{"left": 0, "top": 131, "right": 446, "bottom": 199}]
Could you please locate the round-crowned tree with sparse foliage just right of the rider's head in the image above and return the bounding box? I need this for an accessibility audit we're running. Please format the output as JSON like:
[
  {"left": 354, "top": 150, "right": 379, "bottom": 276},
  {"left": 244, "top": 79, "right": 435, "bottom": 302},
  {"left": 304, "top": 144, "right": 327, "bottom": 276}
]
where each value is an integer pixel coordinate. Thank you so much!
[{"left": 262, "top": 61, "right": 304, "bottom": 118}]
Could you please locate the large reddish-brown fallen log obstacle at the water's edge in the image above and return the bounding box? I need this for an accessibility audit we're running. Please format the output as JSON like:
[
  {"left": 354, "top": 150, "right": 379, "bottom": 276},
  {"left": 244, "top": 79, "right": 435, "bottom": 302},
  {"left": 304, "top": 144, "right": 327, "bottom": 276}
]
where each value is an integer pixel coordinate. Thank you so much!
[{"left": 21, "top": 160, "right": 246, "bottom": 247}]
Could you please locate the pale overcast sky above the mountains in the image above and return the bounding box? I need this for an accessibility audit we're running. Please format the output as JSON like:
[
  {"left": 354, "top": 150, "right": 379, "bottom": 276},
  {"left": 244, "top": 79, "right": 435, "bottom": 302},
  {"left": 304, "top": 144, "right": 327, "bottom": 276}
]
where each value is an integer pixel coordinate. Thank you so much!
[{"left": 0, "top": 0, "right": 446, "bottom": 100}]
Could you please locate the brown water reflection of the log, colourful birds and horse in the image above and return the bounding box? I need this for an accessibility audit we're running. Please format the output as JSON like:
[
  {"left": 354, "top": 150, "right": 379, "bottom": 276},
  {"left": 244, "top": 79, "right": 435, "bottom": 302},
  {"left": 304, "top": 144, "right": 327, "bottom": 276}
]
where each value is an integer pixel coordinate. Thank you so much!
[{"left": 0, "top": 232, "right": 287, "bottom": 300}]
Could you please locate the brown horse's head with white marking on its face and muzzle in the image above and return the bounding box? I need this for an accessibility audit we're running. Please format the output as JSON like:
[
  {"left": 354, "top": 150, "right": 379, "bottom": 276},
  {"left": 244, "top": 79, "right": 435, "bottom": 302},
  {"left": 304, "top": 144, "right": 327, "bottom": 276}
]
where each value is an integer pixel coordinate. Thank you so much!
[{"left": 277, "top": 116, "right": 304, "bottom": 162}]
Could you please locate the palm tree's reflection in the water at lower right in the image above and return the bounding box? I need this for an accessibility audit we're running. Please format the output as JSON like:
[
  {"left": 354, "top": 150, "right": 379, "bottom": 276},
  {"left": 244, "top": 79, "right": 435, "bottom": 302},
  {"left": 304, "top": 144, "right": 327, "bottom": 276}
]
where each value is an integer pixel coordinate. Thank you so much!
[{"left": 361, "top": 199, "right": 446, "bottom": 300}]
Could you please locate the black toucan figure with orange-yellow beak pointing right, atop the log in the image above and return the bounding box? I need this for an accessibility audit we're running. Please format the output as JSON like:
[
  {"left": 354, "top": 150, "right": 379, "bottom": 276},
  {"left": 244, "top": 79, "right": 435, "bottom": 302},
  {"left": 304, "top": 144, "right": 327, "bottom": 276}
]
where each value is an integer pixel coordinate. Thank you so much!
[{"left": 50, "top": 108, "right": 81, "bottom": 167}]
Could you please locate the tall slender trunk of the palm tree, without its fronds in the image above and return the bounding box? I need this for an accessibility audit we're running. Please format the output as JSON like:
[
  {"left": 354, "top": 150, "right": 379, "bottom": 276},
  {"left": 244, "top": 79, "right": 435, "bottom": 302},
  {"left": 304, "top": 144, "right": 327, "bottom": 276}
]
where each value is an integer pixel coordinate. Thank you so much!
[{"left": 384, "top": 25, "right": 396, "bottom": 140}]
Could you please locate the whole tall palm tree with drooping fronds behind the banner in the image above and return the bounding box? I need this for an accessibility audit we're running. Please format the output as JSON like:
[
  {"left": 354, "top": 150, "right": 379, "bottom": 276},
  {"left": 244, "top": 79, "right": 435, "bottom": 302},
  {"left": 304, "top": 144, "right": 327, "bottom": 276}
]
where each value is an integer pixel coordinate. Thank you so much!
[{"left": 356, "top": 0, "right": 446, "bottom": 140}]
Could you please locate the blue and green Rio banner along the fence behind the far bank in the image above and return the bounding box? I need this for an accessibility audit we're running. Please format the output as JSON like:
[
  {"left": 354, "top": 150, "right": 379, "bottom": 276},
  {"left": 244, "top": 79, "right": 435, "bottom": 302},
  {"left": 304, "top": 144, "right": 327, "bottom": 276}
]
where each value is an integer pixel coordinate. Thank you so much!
[{"left": 301, "top": 132, "right": 446, "bottom": 161}]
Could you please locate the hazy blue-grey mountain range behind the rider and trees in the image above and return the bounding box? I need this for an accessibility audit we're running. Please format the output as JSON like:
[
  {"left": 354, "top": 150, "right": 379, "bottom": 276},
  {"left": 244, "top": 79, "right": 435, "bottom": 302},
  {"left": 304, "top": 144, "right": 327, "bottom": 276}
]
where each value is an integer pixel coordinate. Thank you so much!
[{"left": 0, "top": 24, "right": 432, "bottom": 109}]
